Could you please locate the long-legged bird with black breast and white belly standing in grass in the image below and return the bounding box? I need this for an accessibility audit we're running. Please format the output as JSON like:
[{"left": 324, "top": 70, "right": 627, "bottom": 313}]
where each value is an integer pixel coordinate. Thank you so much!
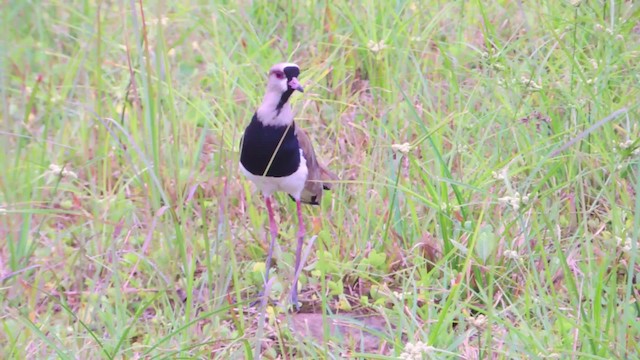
[{"left": 239, "top": 62, "right": 338, "bottom": 309}]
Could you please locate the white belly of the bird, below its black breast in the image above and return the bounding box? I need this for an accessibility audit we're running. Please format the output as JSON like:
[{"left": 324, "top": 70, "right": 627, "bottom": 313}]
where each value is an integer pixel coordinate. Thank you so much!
[{"left": 240, "top": 149, "right": 309, "bottom": 200}]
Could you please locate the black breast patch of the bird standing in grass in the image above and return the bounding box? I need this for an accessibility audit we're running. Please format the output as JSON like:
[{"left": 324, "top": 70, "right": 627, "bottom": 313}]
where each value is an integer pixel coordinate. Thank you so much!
[{"left": 240, "top": 114, "right": 300, "bottom": 177}]
